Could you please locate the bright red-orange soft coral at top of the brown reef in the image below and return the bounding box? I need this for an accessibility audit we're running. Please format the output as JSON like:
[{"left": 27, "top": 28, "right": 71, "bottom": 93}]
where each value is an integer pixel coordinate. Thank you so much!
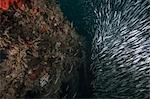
[{"left": 0, "top": 0, "right": 25, "bottom": 11}]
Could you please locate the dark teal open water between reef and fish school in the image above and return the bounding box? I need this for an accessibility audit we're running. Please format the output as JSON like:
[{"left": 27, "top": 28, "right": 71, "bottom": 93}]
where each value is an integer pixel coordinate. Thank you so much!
[{"left": 59, "top": 0, "right": 92, "bottom": 98}]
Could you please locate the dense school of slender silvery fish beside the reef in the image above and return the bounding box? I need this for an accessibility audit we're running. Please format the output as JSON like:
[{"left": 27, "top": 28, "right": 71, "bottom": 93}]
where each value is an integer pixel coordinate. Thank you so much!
[{"left": 86, "top": 0, "right": 150, "bottom": 99}]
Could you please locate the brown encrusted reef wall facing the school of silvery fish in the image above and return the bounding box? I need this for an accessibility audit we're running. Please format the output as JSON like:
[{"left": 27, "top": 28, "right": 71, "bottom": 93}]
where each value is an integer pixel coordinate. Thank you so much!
[{"left": 0, "top": 0, "right": 85, "bottom": 98}]
